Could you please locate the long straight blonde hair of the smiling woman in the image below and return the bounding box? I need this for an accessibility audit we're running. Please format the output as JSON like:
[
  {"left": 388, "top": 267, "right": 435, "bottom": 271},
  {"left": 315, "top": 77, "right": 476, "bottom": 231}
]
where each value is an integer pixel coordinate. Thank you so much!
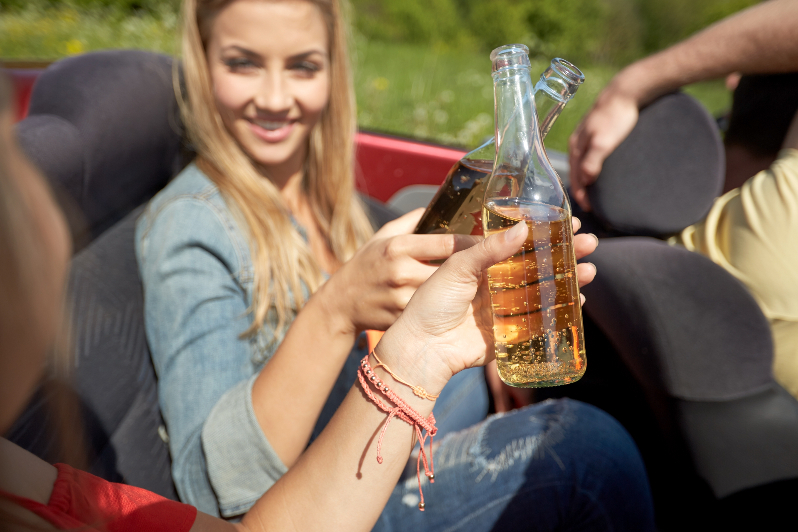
[{"left": 176, "top": 0, "right": 372, "bottom": 335}]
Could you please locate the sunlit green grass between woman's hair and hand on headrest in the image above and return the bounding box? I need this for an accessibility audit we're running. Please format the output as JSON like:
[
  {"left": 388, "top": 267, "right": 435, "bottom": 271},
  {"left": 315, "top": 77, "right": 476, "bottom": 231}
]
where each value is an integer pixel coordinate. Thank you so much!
[{"left": 355, "top": 42, "right": 615, "bottom": 151}]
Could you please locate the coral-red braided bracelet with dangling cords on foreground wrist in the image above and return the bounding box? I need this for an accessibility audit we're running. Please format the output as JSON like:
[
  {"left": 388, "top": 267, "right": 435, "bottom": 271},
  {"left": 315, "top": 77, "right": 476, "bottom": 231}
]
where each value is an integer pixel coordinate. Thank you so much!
[{"left": 357, "top": 355, "right": 438, "bottom": 512}]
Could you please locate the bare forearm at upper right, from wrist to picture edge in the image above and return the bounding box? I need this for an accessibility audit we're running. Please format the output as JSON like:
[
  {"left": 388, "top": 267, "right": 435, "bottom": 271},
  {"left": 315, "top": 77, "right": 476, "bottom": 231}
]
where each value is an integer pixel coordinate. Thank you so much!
[{"left": 610, "top": 0, "right": 798, "bottom": 106}]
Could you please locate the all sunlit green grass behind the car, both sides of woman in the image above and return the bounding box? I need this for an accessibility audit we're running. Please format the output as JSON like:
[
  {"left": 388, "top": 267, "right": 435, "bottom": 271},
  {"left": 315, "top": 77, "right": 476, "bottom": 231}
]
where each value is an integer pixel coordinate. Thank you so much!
[{"left": 0, "top": 8, "right": 730, "bottom": 151}]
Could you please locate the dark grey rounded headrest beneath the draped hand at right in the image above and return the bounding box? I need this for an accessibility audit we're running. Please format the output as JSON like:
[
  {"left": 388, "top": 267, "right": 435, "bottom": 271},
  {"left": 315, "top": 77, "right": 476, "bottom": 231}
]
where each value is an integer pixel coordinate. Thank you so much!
[{"left": 587, "top": 93, "right": 725, "bottom": 237}]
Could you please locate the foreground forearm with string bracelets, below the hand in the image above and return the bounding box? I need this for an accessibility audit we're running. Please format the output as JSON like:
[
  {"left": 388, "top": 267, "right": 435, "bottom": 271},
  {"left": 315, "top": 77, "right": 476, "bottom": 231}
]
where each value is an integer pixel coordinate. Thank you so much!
[{"left": 242, "top": 326, "right": 446, "bottom": 531}]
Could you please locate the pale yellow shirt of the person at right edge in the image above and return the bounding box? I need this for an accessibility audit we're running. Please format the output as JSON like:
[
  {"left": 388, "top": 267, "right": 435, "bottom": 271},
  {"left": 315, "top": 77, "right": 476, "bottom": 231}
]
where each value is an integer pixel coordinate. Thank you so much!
[{"left": 681, "top": 149, "right": 798, "bottom": 397}]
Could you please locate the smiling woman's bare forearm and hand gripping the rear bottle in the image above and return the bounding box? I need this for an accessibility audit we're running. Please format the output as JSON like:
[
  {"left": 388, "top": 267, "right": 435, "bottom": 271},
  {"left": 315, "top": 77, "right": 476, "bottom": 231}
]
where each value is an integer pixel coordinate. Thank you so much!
[{"left": 252, "top": 212, "right": 458, "bottom": 467}]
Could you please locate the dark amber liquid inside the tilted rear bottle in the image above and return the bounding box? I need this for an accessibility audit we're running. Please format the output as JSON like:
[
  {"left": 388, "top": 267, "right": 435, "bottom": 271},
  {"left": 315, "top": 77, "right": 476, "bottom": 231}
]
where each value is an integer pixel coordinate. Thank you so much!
[{"left": 415, "top": 159, "right": 493, "bottom": 235}]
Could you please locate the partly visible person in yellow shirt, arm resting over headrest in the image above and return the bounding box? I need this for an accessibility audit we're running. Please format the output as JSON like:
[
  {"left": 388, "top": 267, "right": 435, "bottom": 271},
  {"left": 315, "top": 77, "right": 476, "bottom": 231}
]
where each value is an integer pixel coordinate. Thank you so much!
[{"left": 569, "top": 0, "right": 798, "bottom": 397}]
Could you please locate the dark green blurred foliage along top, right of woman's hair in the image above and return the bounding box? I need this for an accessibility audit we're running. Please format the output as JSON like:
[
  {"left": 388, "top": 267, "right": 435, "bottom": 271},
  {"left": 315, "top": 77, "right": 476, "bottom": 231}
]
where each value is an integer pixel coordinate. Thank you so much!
[{"left": 351, "top": 0, "right": 758, "bottom": 65}]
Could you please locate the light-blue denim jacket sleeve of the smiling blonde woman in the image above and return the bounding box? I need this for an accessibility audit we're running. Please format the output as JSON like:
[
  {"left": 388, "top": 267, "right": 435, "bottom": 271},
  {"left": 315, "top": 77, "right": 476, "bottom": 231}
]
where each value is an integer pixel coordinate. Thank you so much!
[{"left": 136, "top": 164, "right": 363, "bottom": 517}]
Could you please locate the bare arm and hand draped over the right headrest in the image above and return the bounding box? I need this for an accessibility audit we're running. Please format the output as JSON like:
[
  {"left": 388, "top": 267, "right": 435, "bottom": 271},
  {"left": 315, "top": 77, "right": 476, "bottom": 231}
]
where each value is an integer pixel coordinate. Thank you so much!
[{"left": 568, "top": 0, "right": 798, "bottom": 210}]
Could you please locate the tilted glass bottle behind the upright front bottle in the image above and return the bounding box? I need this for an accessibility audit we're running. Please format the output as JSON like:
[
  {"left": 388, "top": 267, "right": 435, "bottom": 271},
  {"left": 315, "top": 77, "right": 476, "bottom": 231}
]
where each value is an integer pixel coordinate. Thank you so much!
[{"left": 415, "top": 58, "right": 585, "bottom": 235}]
